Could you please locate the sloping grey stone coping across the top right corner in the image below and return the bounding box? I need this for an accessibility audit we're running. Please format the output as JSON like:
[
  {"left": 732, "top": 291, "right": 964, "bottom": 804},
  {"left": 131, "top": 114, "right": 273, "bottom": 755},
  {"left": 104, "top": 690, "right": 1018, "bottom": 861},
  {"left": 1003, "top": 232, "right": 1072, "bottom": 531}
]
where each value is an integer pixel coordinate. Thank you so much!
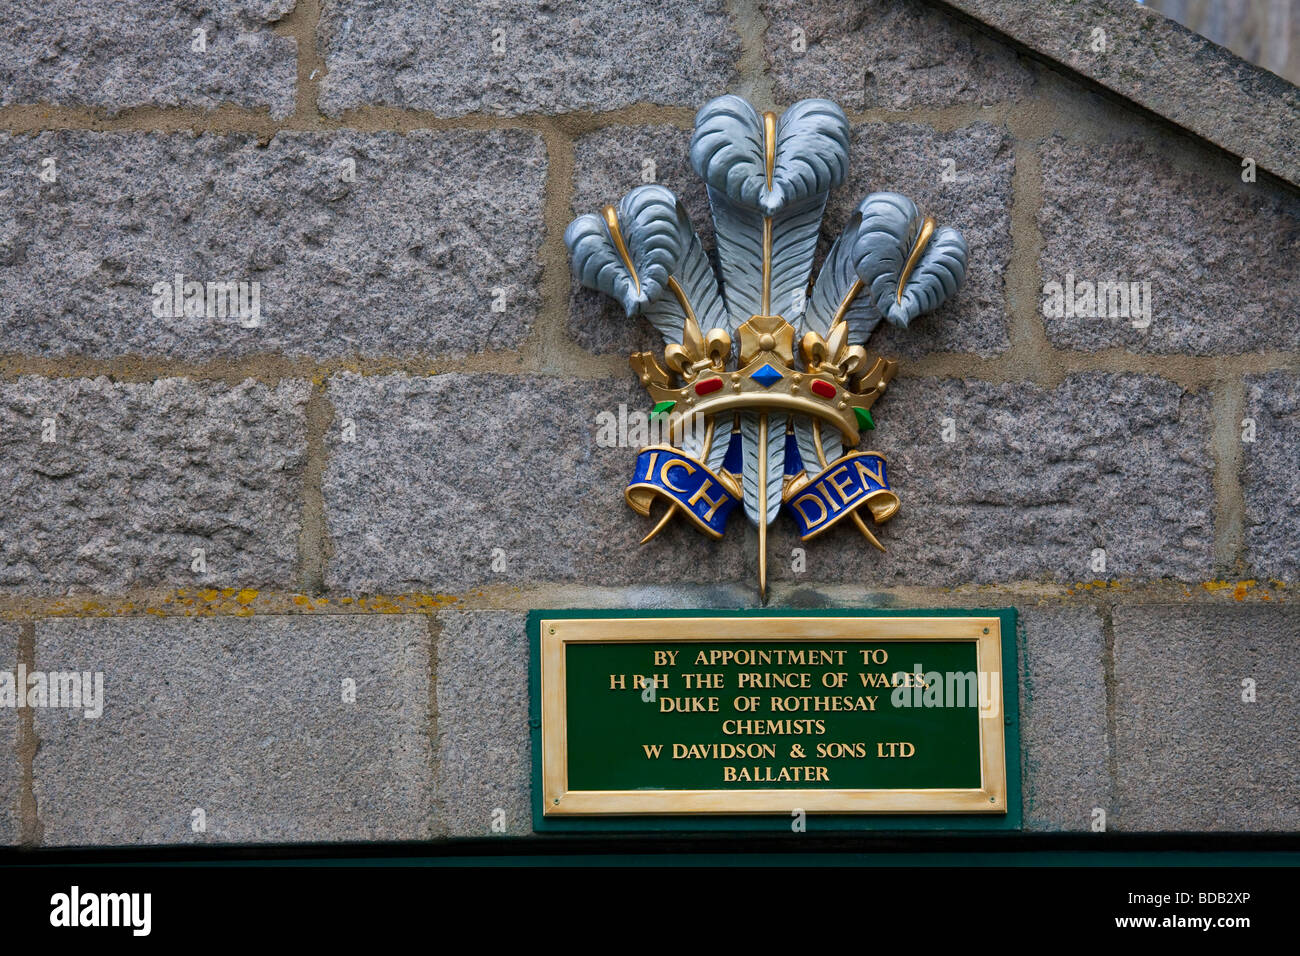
[{"left": 944, "top": 0, "right": 1300, "bottom": 186}]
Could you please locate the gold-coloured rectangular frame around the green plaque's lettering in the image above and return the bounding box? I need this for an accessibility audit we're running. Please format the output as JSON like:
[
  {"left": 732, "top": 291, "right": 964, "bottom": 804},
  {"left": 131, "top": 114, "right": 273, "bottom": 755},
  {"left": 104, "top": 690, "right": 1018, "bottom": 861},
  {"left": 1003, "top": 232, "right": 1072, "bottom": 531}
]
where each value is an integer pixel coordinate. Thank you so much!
[{"left": 538, "top": 615, "right": 1014, "bottom": 817}]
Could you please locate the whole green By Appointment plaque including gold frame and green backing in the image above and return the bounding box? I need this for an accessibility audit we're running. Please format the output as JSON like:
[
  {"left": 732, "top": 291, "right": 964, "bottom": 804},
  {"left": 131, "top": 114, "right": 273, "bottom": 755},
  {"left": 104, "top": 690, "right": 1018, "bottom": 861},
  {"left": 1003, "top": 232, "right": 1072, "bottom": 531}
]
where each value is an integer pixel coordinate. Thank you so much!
[{"left": 529, "top": 609, "right": 1019, "bottom": 830}]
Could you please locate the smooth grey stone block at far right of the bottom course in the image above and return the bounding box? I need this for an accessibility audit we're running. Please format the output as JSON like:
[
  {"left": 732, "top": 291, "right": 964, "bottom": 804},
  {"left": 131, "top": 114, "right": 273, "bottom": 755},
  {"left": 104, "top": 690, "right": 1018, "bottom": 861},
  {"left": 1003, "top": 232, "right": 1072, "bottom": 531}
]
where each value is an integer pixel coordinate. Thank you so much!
[{"left": 1112, "top": 606, "right": 1300, "bottom": 831}]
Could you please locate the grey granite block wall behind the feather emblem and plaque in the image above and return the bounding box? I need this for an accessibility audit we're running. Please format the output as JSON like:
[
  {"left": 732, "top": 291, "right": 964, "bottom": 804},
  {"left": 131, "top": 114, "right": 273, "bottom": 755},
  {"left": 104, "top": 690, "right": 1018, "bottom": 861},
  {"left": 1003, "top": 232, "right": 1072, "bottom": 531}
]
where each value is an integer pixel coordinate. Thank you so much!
[{"left": 0, "top": 0, "right": 1300, "bottom": 845}]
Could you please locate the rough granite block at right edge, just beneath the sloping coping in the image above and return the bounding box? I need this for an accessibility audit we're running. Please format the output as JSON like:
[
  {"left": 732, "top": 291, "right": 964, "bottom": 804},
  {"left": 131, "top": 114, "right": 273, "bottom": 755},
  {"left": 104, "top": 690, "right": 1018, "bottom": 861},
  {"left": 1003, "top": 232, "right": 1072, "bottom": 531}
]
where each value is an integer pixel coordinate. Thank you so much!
[{"left": 1039, "top": 139, "right": 1300, "bottom": 355}]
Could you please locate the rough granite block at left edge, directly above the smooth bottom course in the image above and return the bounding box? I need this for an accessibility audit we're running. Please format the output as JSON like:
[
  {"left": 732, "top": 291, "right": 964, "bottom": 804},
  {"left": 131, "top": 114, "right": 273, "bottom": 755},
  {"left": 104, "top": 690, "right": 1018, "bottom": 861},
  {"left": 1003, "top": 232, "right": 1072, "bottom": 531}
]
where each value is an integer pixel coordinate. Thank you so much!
[{"left": 0, "top": 376, "right": 311, "bottom": 593}]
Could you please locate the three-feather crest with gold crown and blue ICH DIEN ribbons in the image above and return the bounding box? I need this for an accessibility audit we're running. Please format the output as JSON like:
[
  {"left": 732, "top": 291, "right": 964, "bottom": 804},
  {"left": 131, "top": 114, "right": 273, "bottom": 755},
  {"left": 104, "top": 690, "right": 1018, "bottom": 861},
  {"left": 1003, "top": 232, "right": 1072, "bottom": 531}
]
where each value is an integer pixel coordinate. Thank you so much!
[{"left": 564, "top": 96, "right": 967, "bottom": 600}]
